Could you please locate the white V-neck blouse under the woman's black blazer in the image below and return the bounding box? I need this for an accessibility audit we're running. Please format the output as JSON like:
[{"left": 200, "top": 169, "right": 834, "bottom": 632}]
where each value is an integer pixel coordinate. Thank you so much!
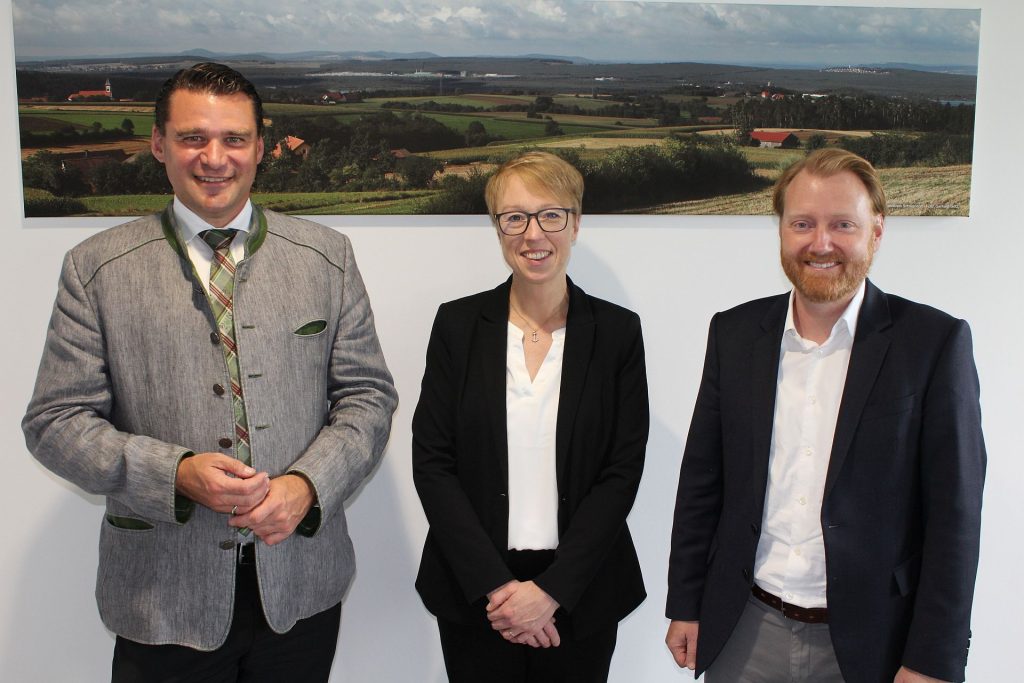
[{"left": 505, "top": 323, "right": 565, "bottom": 550}]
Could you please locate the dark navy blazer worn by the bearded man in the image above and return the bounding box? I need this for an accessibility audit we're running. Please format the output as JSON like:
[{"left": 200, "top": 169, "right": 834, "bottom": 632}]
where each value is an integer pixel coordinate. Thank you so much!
[{"left": 667, "top": 283, "right": 985, "bottom": 683}]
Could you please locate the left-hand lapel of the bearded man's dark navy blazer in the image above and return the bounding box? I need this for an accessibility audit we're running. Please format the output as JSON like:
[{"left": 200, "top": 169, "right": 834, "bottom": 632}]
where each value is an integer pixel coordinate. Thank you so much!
[{"left": 751, "top": 294, "right": 790, "bottom": 510}]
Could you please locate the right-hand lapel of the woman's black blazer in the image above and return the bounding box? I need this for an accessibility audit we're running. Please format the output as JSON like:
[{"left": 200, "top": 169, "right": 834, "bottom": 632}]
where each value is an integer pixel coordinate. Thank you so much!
[{"left": 555, "top": 278, "right": 596, "bottom": 488}]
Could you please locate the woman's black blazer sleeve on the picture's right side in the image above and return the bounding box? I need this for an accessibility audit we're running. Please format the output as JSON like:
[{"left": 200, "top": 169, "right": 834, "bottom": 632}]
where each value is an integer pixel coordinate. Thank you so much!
[{"left": 535, "top": 314, "right": 650, "bottom": 612}]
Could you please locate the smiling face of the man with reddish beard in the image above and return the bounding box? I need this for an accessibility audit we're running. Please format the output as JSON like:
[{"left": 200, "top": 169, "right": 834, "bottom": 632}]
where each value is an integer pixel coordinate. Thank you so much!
[{"left": 778, "top": 171, "right": 885, "bottom": 303}]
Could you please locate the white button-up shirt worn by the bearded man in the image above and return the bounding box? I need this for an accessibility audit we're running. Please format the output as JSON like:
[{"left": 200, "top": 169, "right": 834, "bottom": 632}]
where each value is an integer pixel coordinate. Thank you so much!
[{"left": 754, "top": 283, "right": 864, "bottom": 607}]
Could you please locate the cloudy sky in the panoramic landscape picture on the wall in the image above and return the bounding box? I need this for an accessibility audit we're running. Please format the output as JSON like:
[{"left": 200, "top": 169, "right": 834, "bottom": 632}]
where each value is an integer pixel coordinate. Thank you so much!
[{"left": 13, "top": 0, "right": 981, "bottom": 66}]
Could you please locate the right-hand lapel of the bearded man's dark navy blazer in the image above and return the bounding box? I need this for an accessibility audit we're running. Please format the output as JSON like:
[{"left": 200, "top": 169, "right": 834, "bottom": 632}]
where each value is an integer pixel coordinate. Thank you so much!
[{"left": 824, "top": 281, "right": 892, "bottom": 498}]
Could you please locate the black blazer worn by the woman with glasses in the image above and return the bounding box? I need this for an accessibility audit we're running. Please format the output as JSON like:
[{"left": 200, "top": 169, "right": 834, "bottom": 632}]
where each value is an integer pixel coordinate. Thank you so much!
[{"left": 413, "top": 279, "right": 649, "bottom": 637}]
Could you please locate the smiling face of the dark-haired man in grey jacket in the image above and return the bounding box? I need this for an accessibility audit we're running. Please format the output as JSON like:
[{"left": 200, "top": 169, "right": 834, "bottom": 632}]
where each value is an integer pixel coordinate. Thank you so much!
[{"left": 151, "top": 90, "right": 263, "bottom": 227}]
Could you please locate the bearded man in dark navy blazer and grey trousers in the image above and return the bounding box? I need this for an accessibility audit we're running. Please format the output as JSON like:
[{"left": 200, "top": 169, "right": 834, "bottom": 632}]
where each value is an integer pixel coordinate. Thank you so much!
[{"left": 666, "top": 148, "right": 986, "bottom": 683}]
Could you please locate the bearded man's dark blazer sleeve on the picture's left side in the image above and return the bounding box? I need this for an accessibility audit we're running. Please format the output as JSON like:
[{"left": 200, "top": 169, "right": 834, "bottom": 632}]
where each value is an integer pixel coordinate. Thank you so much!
[{"left": 665, "top": 315, "right": 723, "bottom": 622}]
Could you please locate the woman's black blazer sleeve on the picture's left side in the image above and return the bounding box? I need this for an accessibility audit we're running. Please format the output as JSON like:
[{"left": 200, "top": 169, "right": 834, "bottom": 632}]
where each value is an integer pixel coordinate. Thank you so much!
[{"left": 413, "top": 306, "right": 515, "bottom": 603}]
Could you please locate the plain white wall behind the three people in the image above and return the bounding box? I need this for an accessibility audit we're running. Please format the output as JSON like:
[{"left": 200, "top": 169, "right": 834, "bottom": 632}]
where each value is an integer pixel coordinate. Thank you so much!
[{"left": 0, "top": 0, "right": 1024, "bottom": 683}]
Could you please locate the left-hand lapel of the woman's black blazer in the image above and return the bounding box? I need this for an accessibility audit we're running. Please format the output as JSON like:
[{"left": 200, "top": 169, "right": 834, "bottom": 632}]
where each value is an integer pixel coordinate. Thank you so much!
[{"left": 473, "top": 278, "right": 512, "bottom": 488}]
